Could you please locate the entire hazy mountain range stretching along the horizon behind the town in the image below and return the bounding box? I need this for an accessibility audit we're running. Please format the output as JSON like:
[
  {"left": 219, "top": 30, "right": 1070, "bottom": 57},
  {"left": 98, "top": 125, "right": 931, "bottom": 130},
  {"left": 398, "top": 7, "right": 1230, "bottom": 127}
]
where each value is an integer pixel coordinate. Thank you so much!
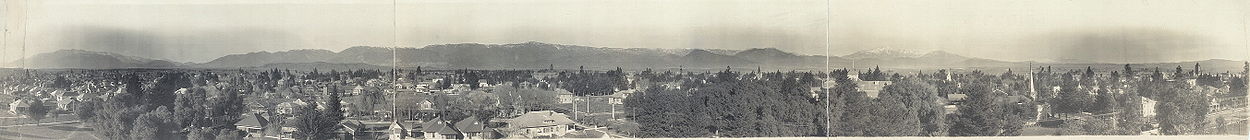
[{"left": 11, "top": 41, "right": 1241, "bottom": 70}]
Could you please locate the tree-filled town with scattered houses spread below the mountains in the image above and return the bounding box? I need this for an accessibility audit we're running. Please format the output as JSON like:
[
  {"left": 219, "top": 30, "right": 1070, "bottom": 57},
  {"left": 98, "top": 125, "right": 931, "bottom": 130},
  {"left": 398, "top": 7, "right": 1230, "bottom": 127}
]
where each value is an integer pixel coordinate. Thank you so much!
[{"left": 0, "top": 64, "right": 1250, "bottom": 140}]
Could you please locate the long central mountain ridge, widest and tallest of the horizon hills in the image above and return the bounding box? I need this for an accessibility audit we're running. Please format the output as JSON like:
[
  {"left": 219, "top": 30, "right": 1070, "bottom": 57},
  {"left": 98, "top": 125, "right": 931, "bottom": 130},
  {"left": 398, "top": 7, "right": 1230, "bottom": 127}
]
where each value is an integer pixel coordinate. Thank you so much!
[{"left": 194, "top": 41, "right": 824, "bottom": 69}]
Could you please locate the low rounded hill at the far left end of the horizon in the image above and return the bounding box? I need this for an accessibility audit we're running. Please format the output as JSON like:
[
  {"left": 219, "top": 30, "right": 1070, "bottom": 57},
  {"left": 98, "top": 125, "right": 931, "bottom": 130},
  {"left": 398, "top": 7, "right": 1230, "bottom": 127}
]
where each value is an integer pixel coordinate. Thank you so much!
[{"left": 9, "top": 50, "right": 180, "bottom": 69}]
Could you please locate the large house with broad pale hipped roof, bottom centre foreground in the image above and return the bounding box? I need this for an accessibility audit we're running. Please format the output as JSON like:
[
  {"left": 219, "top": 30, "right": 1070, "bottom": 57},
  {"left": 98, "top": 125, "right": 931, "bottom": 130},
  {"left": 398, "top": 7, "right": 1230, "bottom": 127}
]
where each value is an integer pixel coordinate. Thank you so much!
[{"left": 504, "top": 110, "right": 574, "bottom": 139}]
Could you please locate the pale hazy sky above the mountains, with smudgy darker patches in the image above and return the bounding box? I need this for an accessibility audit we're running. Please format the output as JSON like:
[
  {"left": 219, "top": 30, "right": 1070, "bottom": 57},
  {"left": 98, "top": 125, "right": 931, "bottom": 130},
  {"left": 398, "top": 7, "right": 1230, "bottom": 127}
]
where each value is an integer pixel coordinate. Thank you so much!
[{"left": 0, "top": 0, "right": 1250, "bottom": 63}]
